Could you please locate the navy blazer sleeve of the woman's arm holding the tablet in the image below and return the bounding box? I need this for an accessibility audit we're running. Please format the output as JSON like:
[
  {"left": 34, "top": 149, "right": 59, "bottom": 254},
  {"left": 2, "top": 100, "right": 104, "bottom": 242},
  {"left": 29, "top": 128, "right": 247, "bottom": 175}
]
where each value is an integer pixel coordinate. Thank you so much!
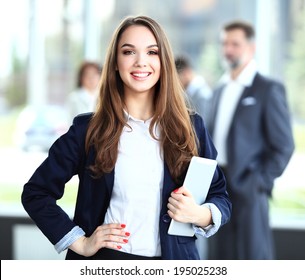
[{"left": 193, "top": 115, "right": 232, "bottom": 225}]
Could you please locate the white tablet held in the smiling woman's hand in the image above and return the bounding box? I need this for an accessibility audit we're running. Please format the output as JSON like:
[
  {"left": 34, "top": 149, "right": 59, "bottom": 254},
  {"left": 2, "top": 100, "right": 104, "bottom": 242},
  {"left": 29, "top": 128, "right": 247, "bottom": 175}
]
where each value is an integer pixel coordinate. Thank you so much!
[{"left": 168, "top": 156, "right": 217, "bottom": 236}]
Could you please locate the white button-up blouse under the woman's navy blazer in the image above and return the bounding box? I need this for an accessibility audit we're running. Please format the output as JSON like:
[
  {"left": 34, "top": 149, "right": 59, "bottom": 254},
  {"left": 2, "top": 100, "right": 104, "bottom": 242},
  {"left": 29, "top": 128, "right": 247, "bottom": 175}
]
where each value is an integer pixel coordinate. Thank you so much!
[{"left": 104, "top": 112, "right": 164, "bottom": 257}]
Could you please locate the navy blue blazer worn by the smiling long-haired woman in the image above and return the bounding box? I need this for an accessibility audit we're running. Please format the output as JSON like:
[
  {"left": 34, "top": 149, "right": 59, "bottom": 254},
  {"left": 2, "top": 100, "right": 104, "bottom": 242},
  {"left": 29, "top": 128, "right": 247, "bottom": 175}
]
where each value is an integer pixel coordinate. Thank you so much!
[{"left": 22, "top": 114, "right": 231, "bottom": 259}]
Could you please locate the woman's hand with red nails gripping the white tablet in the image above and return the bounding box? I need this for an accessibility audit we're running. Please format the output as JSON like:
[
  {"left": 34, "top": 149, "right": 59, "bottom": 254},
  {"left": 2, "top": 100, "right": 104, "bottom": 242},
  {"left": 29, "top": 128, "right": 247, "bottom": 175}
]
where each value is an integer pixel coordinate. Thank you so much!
[{"left": 167, "top": 186, "right": 212, "bottom": 227}]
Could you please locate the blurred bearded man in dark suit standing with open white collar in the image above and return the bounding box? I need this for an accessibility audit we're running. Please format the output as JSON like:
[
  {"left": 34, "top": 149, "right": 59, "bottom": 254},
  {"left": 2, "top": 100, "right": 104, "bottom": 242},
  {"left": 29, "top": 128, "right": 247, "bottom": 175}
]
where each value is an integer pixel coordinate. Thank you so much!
[{"left": 205, "top": 21, "right": 294, "bottom": 260}]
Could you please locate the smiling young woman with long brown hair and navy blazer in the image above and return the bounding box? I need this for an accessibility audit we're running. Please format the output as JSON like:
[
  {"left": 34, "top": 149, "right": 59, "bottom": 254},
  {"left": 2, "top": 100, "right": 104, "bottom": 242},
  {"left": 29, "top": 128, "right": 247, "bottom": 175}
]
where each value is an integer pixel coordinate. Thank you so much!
[{"left": 22, "top": 16, "right": 231, "bottom": 259}]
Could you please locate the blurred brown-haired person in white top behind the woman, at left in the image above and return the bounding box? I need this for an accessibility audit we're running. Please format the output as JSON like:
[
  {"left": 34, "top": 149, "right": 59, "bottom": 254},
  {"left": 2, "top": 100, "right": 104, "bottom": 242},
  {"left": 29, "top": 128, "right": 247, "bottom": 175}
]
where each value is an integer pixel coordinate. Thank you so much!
[{"left": 67, "top": 61, "right": 102, "bottom": 120}]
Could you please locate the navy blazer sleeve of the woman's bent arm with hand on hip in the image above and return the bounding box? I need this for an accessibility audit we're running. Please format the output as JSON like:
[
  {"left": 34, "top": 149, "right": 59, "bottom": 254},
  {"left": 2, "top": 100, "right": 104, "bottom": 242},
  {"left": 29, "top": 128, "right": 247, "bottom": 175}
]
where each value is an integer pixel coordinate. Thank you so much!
[{"left": 21, "top": 114, "right": 88, "bottom": 245}]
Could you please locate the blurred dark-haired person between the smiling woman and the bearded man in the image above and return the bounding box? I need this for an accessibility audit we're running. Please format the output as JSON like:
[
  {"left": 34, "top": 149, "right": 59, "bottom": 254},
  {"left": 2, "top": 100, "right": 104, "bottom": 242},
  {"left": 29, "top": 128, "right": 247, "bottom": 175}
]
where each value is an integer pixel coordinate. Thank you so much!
[{"left": 175, "top": 55, "right": 212, "bottom": 122}]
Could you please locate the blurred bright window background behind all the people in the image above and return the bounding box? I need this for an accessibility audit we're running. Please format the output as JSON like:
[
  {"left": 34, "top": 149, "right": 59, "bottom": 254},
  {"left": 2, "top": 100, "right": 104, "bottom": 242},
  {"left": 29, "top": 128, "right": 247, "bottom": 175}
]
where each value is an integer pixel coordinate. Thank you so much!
[{"left": 0, "top": 0, "right": 305, "bottom": 259}]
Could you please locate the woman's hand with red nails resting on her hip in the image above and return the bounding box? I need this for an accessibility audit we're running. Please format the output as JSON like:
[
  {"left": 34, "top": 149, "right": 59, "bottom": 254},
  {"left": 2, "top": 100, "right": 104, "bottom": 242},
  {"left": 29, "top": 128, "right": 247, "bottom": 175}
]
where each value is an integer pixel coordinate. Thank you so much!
[{"left": 69, "top": 224, "right": 130, "bottom": 257}]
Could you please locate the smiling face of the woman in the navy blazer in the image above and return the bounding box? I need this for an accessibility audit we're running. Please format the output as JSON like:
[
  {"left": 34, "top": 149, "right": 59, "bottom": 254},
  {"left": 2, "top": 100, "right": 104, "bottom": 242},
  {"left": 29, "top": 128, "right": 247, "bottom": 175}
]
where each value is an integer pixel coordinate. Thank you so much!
[{"left": 117, "top": 25, "right": 161, "bottom": 96}]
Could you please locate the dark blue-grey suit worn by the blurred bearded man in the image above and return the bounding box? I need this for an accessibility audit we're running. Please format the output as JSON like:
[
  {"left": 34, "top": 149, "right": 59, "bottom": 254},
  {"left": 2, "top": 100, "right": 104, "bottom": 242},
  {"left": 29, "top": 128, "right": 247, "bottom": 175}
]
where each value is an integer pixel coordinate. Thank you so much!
[{"left": 208, "top": 73, "right": 294, "bottom": 259}]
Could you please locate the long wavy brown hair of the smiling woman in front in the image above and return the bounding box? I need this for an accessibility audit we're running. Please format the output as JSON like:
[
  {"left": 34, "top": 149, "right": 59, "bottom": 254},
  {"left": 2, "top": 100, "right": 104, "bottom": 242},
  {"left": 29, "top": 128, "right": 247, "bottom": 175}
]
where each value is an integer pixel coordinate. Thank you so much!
[{"left": 86, "top": 16, "right": 198, "bottom": 180}]
